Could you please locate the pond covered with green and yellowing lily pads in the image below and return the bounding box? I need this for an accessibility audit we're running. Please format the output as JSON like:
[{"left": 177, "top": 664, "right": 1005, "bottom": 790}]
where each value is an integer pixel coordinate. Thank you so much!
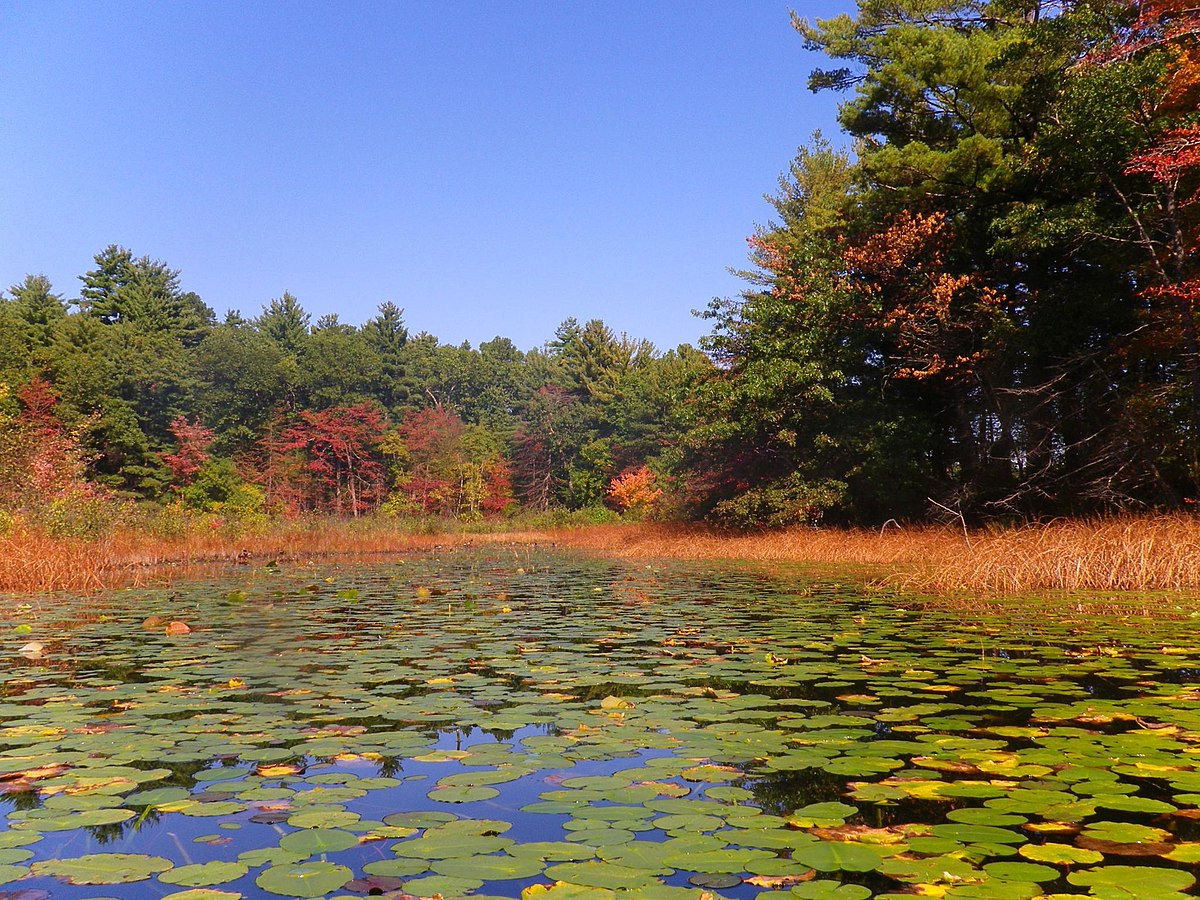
[{"left": 0, "top": 548, "right": 1200, "bottom": 900}]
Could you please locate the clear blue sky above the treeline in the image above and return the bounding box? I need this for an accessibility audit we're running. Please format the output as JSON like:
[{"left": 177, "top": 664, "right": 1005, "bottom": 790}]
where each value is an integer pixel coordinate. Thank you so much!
[{"left": 0, "top": 0, "right": 853, "bottom": 349}]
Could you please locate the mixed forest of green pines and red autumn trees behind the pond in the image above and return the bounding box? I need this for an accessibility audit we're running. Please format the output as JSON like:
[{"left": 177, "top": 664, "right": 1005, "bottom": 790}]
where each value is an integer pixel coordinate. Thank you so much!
[{"left": 0, "top": 0, "right": 1200, "bottom": 536}]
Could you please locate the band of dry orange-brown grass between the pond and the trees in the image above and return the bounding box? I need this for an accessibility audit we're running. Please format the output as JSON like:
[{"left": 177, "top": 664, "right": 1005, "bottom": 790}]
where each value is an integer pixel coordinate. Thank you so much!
[{"left": 7, "top": 516, "right": 1200, "bottom": 596}]
